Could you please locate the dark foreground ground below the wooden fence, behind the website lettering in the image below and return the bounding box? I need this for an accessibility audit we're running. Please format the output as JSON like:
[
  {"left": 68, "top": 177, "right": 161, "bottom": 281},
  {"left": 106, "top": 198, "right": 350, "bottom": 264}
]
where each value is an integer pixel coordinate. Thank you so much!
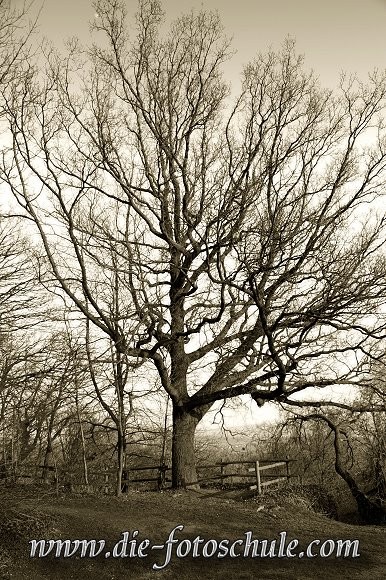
[{"left": 0, "top": 487, "right": 386, "bottom": 580}]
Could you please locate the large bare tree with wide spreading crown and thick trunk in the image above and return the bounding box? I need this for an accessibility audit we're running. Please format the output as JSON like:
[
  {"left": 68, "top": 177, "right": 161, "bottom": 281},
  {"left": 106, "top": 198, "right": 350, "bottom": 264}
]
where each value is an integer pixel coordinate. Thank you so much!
[{"left": 2, "top": 0, "right": 386, "bottom": 487}]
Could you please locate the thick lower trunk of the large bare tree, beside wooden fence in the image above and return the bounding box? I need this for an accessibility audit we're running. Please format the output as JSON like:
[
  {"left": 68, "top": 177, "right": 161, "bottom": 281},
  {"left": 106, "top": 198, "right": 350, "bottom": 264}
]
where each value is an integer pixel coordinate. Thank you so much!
[{"left": 172, "top": 405, "right": 199, "bottom": 489}]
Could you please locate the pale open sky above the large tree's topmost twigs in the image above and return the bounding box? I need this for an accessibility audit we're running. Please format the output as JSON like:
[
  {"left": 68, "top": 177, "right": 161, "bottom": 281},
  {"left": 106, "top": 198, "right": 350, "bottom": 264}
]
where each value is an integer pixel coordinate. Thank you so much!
[{"left": 36, "top": 0, "right": 386, "bottom": 86}]
